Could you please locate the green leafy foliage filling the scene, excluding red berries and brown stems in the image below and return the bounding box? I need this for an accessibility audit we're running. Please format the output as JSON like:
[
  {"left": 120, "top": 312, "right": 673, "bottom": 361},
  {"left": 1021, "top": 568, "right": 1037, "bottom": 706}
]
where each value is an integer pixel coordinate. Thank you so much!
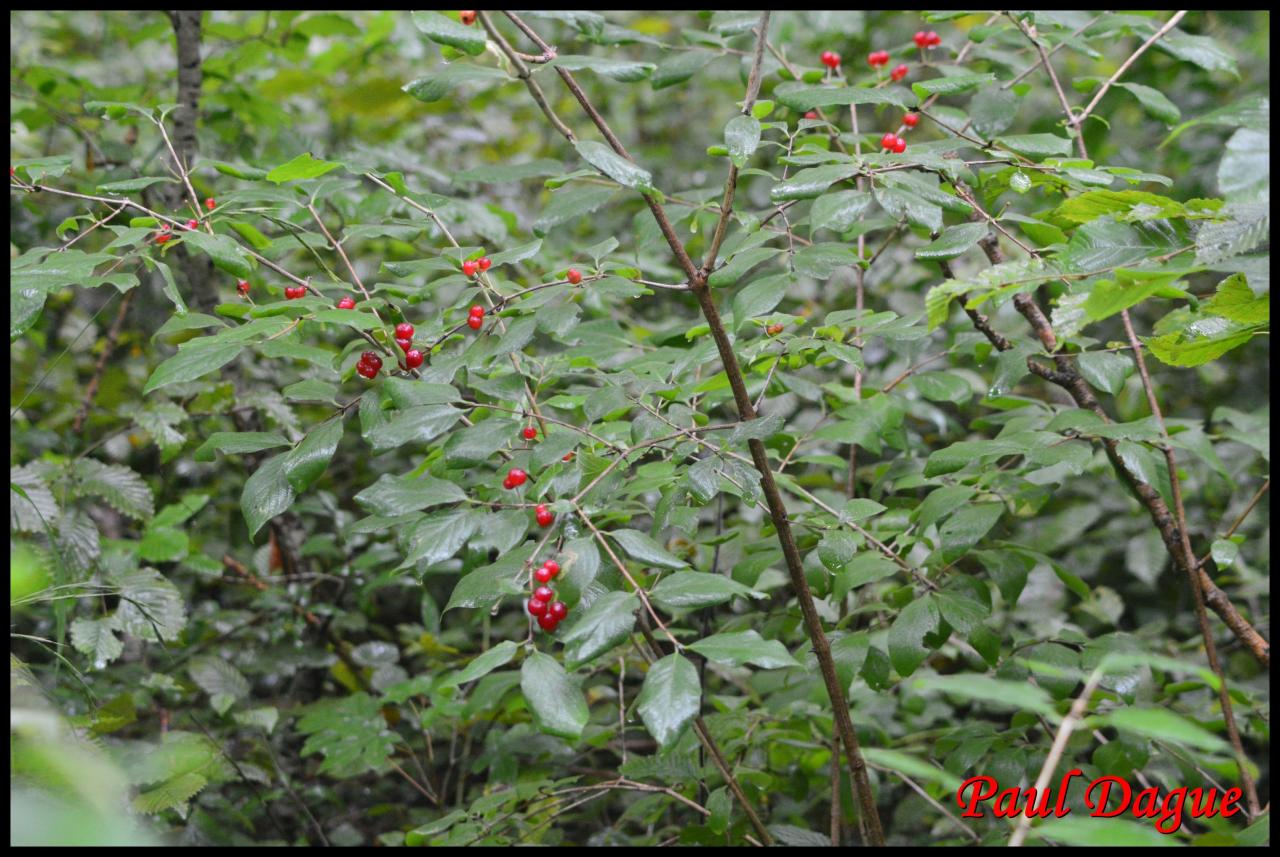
[{"left": 10, "top": 12, "right": 1270, "bottom": 845}]
